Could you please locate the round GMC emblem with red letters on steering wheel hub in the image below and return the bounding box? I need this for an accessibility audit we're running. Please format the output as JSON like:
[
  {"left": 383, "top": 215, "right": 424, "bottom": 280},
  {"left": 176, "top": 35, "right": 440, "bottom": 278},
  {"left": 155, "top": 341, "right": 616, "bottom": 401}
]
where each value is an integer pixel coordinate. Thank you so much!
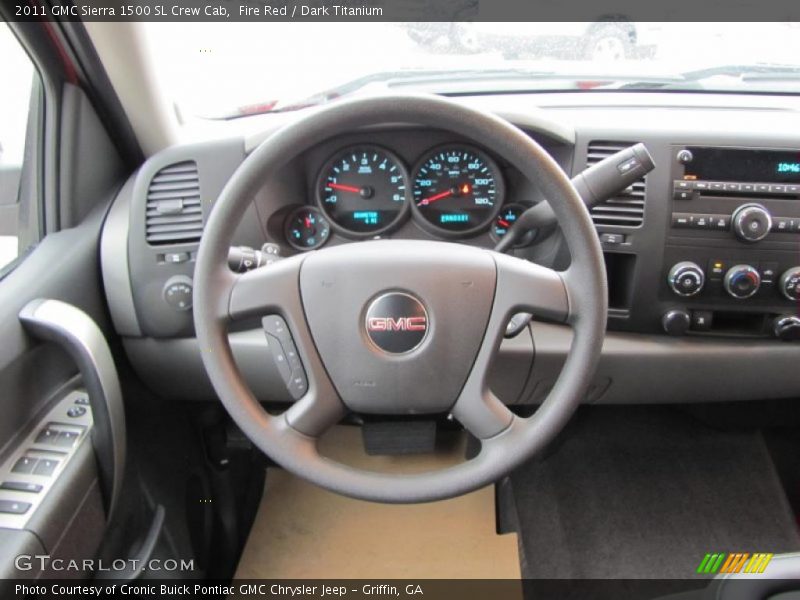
[{"left": 364, "top": 292, "right": 428, "bottom": 354}]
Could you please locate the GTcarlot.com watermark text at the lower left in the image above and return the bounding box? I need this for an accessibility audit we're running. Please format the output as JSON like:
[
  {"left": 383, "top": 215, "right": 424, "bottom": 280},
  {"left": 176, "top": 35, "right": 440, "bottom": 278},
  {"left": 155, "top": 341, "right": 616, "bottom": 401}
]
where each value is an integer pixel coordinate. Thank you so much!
[{"left": 14, "top": 554, "right": 194, "bottom": 573}]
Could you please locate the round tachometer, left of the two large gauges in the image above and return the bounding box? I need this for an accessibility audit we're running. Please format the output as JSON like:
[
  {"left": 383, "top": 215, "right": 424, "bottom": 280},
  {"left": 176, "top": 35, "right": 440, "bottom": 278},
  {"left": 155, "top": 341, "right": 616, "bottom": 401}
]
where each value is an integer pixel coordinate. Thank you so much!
[{"left": 317, "top": 146, "right": 410, "bottom": 237}]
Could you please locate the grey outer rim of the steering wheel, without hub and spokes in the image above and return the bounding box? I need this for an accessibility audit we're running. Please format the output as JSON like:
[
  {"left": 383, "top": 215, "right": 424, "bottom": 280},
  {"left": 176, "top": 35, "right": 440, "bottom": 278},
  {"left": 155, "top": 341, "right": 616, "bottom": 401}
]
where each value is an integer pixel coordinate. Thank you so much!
[{"left": 194, "top": 94, "right": 607, "bottom": 503}]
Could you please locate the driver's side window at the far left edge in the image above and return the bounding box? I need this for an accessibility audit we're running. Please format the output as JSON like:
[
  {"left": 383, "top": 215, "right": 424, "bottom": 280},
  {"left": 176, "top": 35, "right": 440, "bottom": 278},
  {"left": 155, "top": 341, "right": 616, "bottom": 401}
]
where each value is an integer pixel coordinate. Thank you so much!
[{"left": 0, "top": 22, "right": 38, "bottom": 270}]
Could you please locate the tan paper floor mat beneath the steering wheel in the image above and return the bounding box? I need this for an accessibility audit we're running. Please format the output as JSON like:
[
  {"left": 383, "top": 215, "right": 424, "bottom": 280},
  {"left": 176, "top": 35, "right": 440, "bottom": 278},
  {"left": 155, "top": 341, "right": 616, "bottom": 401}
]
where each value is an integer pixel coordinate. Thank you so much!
[{"left": 236, "top": 427, "right": 520, "bottom": 579}]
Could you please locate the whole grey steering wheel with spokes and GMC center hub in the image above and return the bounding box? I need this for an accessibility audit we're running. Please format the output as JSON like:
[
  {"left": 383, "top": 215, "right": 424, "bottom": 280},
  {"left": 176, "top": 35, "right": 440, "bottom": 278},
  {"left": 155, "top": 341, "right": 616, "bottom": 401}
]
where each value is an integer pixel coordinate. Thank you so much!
[{"left": 194, "top": 95, "right": 607, "bottom": 503}]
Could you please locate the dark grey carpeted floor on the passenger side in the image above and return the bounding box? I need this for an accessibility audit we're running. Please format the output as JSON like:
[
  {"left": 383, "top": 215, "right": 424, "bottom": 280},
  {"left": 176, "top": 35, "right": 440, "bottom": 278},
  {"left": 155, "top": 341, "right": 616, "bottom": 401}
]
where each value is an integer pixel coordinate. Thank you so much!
[{"left": 512, "top": 407, "right": 800, "bottom": 579}]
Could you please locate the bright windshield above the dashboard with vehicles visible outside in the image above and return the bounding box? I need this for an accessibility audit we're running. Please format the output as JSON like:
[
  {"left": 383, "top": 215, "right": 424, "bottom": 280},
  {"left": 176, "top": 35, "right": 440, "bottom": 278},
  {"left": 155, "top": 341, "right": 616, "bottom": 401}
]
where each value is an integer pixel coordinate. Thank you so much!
[{"left": 143, "top": 21, "right": 800, "bottom": 119}]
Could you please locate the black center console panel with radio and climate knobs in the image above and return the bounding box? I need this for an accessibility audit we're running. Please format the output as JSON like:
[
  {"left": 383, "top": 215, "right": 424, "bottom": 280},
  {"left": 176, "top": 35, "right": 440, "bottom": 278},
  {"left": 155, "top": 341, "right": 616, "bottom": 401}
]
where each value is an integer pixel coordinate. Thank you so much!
[{"left": 658, "top": 146, "right": 800, "bottom": 340}]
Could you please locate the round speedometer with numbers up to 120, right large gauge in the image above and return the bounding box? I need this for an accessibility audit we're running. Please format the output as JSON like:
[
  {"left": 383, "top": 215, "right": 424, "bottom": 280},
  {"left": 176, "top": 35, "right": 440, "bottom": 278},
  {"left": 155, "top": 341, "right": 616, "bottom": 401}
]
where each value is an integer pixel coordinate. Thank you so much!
[{"left": 412, "top": 145, "right": 505, "bottom": 236}]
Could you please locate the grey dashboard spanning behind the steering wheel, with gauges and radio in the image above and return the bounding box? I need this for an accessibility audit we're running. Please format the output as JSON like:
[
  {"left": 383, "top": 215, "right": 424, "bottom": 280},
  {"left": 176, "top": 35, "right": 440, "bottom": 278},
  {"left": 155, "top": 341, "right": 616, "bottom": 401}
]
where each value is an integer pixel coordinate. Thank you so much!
[{"left": 101, "top": 94, "right": 800, "bottom": 412}]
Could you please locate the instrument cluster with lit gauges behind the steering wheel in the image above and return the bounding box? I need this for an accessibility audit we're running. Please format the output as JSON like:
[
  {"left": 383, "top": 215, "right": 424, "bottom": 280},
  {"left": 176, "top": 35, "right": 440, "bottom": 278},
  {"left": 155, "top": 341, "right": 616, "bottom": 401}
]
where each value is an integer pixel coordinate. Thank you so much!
[{"left": 284, "top": 143, "right": 510, "bottom": 250}]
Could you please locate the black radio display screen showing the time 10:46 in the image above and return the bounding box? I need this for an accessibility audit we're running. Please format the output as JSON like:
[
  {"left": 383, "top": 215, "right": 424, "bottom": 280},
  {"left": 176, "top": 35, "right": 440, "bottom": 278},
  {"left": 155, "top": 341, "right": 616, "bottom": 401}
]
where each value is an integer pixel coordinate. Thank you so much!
[{"left": 684, "top": 148, "right": 800, "bottom": 183}]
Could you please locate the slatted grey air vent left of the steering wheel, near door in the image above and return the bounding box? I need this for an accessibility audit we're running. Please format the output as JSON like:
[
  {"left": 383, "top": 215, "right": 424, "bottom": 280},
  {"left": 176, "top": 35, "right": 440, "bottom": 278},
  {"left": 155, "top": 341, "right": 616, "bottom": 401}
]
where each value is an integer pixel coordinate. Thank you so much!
[{"left": 145, "top": 161, "right": 203, "bottom": 245}]
